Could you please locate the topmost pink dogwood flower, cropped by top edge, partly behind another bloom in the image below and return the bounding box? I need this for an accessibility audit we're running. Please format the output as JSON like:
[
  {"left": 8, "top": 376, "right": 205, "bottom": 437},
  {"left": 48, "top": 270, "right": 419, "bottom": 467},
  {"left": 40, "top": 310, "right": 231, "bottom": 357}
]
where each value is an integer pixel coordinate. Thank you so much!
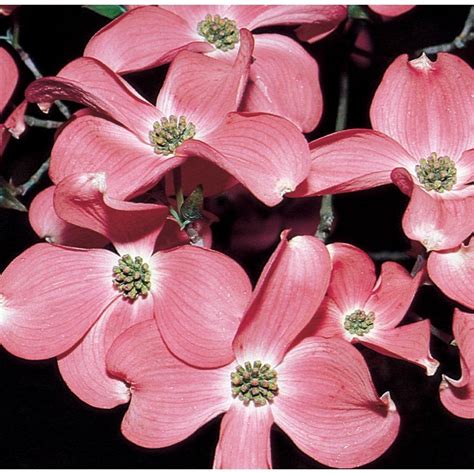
[{"left": 84, "top": 5, "right": 345, "bottom": 132}]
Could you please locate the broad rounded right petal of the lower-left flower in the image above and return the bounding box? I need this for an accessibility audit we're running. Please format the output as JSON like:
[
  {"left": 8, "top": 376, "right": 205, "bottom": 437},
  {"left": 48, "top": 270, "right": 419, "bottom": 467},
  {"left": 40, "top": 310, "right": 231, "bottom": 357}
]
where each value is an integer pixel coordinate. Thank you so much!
[{"left": 151, "top": 246, "right": 252, "bottom": 367}]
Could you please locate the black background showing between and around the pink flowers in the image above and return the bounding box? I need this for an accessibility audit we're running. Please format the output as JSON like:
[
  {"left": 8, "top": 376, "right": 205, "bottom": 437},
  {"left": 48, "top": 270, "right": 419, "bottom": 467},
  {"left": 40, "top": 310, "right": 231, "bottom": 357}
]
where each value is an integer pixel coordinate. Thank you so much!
[{"left": 0, "top": 6, "right": 474, "bottom": 468}]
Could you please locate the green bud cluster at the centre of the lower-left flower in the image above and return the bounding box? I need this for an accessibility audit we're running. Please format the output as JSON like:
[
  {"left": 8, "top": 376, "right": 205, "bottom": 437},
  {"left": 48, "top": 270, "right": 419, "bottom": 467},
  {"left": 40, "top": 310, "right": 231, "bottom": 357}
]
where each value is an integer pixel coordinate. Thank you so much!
[{"left": 113, "top": 255, "right": 151, "bottom": 300}]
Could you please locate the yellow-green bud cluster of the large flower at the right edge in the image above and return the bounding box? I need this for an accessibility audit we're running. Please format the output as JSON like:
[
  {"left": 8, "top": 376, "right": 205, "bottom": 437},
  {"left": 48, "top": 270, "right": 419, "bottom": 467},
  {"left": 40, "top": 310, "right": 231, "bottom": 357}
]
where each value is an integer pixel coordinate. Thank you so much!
[{"left": 415, "top": 152, "right": 456, "bottom": 193}]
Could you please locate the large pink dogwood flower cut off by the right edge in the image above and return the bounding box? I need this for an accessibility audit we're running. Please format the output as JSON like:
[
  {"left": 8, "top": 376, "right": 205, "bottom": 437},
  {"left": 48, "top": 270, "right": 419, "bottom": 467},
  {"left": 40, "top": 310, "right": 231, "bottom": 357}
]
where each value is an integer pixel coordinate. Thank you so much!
[{"left": 293, "top": 53, "right": 474, "bottom": 250}]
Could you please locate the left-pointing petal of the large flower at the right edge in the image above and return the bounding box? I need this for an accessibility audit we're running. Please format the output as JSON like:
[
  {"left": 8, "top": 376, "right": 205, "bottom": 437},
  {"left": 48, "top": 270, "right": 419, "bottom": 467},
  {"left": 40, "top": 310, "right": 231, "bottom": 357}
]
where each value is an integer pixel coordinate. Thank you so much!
[{"left": 292, "top": 129, "right": 413, "bottom": 197}]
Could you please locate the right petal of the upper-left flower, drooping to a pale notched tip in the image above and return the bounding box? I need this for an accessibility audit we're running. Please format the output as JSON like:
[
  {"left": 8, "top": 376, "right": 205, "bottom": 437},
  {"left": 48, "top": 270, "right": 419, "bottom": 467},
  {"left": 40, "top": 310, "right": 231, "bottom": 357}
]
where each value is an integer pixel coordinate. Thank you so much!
[{"left": 180, "top": 113, "right": 309, "bottom": 206}]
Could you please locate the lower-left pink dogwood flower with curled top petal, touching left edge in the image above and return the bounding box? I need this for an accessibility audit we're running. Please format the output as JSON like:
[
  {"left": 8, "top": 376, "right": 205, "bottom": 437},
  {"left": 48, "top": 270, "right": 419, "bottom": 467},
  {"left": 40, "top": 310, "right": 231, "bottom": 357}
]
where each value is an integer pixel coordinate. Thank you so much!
[{"left": 0, "top": 174, "right": 251, "bottom": 408}]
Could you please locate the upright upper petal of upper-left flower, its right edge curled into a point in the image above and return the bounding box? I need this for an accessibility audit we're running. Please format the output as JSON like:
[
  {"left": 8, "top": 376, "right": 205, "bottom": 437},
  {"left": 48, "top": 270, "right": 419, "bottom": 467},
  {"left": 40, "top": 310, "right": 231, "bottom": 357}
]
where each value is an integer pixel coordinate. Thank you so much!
[{"left": 156, "top": 30, "right": 253, "bottom": 139}]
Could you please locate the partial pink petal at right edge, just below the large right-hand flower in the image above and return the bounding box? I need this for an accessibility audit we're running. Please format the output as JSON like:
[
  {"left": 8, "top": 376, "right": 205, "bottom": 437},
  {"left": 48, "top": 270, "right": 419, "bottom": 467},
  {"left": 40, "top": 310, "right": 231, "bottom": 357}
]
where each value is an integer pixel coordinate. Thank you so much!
[{"left": 428, "top": 240, "right": 474, "bottom": 309}]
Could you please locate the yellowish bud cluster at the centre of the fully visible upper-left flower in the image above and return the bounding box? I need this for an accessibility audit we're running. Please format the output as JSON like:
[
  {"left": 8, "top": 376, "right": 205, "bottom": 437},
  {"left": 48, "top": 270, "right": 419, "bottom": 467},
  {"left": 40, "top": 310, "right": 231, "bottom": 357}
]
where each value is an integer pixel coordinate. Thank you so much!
[{"left": 150, "top": 115, "right": 196, "bottom": 156}]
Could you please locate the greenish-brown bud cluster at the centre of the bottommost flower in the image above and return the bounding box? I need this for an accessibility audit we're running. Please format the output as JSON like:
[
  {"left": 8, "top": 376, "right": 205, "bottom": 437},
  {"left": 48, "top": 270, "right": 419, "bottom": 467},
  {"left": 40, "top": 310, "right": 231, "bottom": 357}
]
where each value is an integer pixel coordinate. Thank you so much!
[{"left": 230, "top": 360, "right": 278, "bottom": 406}]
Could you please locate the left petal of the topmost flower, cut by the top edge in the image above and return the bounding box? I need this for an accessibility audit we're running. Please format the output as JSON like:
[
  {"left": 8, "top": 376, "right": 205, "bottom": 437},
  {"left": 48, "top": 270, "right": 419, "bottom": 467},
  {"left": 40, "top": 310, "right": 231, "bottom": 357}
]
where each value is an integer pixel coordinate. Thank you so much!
[{"left": 84, "top": 6, "right": 212, "bottom": 74}]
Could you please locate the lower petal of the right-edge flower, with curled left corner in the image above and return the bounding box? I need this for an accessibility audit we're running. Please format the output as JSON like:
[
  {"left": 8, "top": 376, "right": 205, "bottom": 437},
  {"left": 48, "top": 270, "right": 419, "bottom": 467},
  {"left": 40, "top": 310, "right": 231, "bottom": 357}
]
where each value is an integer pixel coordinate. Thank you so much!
[{"left": 392, "top": 168, "right": 474, "bottom": 251}]
